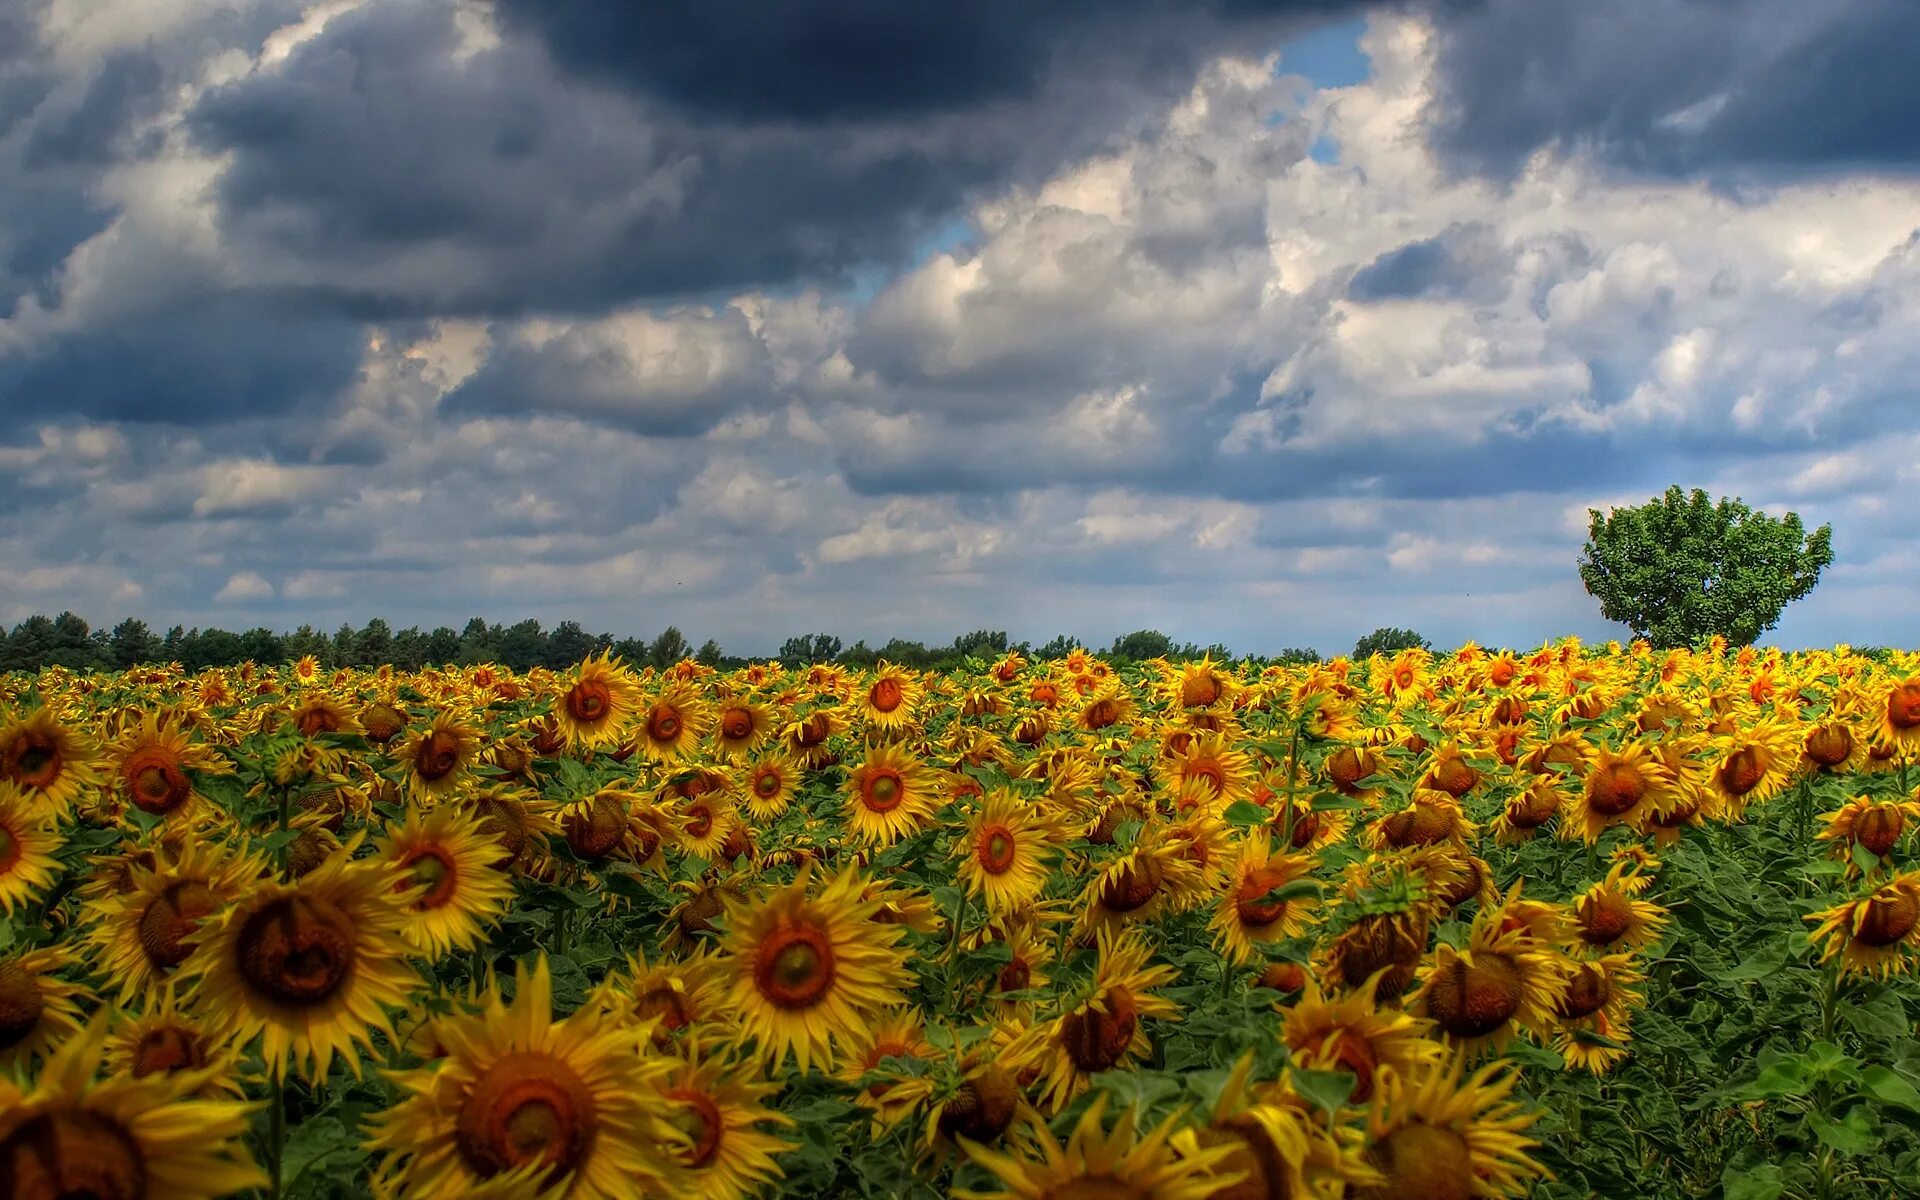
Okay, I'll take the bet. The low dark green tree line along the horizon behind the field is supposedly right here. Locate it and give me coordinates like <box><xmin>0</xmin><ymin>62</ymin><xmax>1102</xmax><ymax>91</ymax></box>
<box><xmin>0</xmin><ymin>612</ymin><xmax>1351</xmax><ymax>672</ymax></box>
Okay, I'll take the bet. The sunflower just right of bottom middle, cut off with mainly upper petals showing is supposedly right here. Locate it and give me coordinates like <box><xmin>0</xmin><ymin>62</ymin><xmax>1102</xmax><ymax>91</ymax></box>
<box><xmin>954</xmin><ymin>1094</ymin><xmax>1240</xmax><ymax>1200</ymax></box>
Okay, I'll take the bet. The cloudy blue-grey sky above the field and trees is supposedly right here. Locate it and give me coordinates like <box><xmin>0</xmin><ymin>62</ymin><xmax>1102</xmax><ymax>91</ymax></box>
<box><xmin>0</xmin><ymin>0</ymin><xmax>1920</xmax><ymax>653</ymax></box>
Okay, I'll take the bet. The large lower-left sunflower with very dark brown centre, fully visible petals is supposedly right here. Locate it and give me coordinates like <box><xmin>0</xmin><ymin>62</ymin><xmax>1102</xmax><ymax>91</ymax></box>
<box><xmin>182</xmin><ymin>837</ymin><xmax>419</xmax><ymax>1079</ymax></box>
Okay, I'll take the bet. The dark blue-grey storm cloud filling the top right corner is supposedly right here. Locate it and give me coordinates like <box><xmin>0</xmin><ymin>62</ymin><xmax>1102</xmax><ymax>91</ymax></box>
<box><xmin>1440</xmin><ymin>0</ymin><xmax>1920</xmax><ymax>179</ymax></box>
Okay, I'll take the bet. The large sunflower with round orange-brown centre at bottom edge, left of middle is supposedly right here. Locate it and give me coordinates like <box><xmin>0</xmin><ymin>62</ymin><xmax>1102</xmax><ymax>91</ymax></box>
<box><xmin>367</xmin><ymin>956</ymin><xmax>687</xmax><ymax>1200</ymax></box>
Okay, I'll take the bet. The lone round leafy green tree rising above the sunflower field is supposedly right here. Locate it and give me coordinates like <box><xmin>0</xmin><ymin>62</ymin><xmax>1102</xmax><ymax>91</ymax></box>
<box><xmin>1580</xmin><ymin>484</ymin><xmax>1834</xmax><ymax>649</ymax></box>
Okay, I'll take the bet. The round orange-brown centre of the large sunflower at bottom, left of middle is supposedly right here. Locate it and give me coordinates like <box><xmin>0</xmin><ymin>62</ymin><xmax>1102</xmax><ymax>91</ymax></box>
<box><xmin>455</xmin><ymin>1052</ymin><xmax>599</xmax><ymax>1177</ymax></box>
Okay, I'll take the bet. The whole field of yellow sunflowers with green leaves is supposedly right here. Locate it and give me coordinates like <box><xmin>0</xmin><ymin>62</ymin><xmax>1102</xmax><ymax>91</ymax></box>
<box><xmin>0</xmin><ymin>641</ymin><xmax>1920</xmax><ymax>1200</ymax></box>
